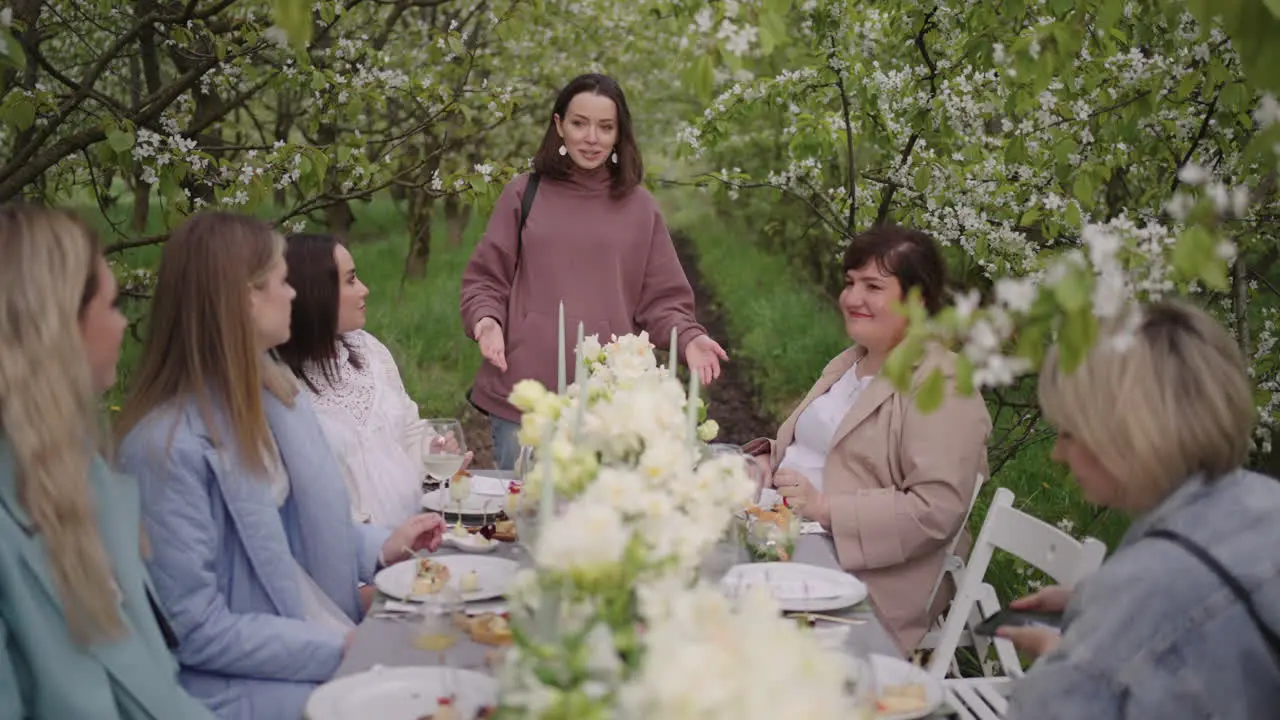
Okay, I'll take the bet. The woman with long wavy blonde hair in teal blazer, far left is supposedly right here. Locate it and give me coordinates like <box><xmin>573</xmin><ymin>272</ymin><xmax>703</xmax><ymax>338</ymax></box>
<box><xmin>0</xmin><ymin>208</ymin><xmax>209</xmax><ymax>720</ymax></box>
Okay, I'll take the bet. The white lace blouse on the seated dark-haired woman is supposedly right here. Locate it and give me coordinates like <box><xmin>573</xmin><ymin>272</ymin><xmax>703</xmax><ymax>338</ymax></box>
<box><xmin>305</xmin><ymin>331</ymin><xmax>431</xmax><ymax>528</ymax></box>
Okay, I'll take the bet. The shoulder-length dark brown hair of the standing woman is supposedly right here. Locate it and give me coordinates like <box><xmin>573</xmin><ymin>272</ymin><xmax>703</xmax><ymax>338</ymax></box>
<box><xmin>534</xmin><ymin>73</ymin><xmax>644</xmax><ymax>197</ymax></box>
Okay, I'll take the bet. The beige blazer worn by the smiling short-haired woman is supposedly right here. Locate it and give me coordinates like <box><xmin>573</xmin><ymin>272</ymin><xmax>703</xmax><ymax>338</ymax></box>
<box><xmin>746</xmin><ymin>346</ymin><xmax>991</xmax><ymax>653</ymax></box>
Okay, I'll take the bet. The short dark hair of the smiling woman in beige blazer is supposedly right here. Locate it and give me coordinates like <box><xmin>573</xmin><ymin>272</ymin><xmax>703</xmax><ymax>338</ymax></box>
<box><xmin>844</xmin><ymin>224</ymin><xmax>947</xmax><ymax>315</ymax></box>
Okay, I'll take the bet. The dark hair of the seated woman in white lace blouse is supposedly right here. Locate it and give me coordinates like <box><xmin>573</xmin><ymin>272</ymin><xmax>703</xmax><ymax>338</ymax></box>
<box><xmin>275</xmin><ymin>233</ymin><xmax>364</xmax><ymax>393</ymax></box>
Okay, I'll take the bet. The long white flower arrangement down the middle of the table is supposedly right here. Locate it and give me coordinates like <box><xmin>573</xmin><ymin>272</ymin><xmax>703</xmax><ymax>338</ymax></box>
<box><xmin>499</xmin><ymin>333</ymin><xmax>850</xmax><ymax>720</ymax></box>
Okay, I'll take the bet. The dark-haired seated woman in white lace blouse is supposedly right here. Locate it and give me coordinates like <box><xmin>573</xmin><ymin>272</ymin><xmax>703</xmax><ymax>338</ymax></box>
<box><xmin>276</xmin><ymin>234</ymin><xmax>470</xmax><ymax>528</ymax></box>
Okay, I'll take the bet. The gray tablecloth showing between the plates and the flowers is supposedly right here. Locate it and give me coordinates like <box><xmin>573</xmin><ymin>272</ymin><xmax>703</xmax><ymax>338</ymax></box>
<box><xmin>337</xmin><ymin>536</ymin><xmax>901</xmax><ymax>678</ymax></box>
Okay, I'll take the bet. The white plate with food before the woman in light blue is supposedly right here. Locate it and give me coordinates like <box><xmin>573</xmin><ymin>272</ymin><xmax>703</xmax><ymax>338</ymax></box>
<box><xmin>374</xmin><ymin>555</ymin><xmax>520</xmax><ymax>602</ymax></box>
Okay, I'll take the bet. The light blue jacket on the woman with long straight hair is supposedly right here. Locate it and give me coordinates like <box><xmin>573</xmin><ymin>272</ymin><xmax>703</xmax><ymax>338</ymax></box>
<box><xmin>119</xmin><ymin>391</ymin><xmax>389</xmax><ymax>720</ymax></box>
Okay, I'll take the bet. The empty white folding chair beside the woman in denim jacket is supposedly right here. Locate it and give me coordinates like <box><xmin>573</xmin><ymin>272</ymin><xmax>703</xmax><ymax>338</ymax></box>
<box><xmin>928</xmin><ymin>488</ymin><xmax>1107</xmax><ymax>679</ymax></box>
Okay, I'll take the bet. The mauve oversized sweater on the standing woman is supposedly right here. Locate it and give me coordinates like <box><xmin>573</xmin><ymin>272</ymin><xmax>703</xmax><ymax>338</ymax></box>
<box><xmin>461</xmin><ymin>167</ymin><xmax>707</xmax><ymax>421</ymax></box>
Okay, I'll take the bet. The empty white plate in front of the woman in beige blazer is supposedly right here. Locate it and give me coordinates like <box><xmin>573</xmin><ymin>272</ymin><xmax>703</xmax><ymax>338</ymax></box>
<box><xmin>721</xmin><ymin>562</ymin><xmax>867</xmax><ymax>612</ymax></box>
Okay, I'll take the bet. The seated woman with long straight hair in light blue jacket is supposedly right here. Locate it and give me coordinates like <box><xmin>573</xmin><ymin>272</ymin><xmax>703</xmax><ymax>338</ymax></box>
<box><xmin>112</xmin><ymin>213</ymin><xmax>443</xmax><ymax>720</ymax></box>
